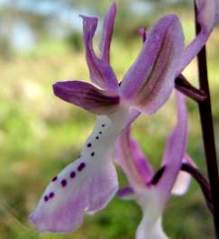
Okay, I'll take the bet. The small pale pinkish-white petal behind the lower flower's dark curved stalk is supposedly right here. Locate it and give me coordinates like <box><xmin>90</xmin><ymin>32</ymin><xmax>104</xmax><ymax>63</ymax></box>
<box><xmin>171</xmin><ymin>154</ymin><xmax>195</xmax><ymax>196</ymax></box>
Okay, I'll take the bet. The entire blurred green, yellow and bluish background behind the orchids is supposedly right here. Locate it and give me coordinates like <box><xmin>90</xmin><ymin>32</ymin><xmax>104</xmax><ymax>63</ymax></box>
<box><xmin>0</xmin><ymin>0</ymin><xmax>219</xmax><ymax>239</ymax></box>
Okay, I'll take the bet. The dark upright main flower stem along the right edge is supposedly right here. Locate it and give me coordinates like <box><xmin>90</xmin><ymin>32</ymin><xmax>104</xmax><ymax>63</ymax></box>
<box><xmin>195</xmin><ymin>3</ymin><xmax>219</xmax><ymax>239</ymax></box>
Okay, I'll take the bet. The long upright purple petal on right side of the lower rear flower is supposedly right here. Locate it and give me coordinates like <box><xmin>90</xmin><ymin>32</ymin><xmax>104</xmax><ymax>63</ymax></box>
<box><xmin>157</xmin><ymin>93</ymin><xmax>188</xmax><ymax>203</ymax></box>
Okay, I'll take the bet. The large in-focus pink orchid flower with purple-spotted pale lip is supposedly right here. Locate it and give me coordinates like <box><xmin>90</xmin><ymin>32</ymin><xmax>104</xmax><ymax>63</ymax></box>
<box><xmin>30</xmin><ymin>0</ymin><xmax>216</xmax><ymax>232</ymax></box>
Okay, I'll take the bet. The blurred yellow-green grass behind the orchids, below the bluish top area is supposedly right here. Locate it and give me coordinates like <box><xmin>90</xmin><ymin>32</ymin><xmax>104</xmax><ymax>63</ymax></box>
<box><xmin>0</xmin><ymin>13</ymin><xmax>219</xmax><ymax>239</ymax></box>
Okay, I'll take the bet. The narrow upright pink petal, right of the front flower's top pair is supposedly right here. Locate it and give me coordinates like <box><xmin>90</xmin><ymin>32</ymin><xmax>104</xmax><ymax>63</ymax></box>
<box><xmin>100</xmin><ymin>3</ymin><xmax>117</xmax><ymax>63</ymax></box>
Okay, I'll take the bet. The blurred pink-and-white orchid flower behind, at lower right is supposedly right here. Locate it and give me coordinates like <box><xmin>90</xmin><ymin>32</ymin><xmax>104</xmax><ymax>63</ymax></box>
<box><xmin>116</xmin><ymin>93</ymin><xmax>191</xmax><ymax>239</ymax></box>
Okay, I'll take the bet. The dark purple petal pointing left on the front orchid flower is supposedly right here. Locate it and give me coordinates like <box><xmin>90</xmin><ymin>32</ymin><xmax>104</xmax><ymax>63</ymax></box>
<box><xmin>53</xmin><ymin>81</ymin><xmax>119</xmax><ymax>114</ymax></box>
